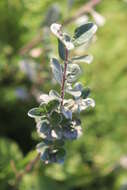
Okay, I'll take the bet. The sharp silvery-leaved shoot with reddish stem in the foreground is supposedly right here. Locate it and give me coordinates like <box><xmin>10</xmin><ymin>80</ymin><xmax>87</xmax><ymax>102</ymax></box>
<box><xmin>28</xmin><ymin>23</ymin><xmax>97</xmax><ymax>164</ymax></box>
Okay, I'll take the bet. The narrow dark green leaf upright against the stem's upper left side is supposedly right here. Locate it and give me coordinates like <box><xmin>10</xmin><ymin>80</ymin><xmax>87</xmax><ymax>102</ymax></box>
<box><xmin>58</xmin><ymin>39</ymin><xmax>66</xmax><ymax>60</ymax></box>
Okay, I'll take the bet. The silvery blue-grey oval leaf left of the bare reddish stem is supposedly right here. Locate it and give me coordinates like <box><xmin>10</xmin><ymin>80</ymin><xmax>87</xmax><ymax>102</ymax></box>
<box><xmin>51</xmin><ymin>58</ymin><xmax>63</xmax><ymax>84</ymax></box>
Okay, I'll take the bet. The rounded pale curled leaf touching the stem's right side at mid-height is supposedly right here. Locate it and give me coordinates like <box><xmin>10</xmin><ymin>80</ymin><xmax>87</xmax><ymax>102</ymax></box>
<box><xmin>67</xmin><ymin>64</ymin><xmax>81</xmax><ymax>83</ymax></box>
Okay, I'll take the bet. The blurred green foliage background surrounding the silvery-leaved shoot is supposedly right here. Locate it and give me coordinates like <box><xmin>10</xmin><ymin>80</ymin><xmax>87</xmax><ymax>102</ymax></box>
<box><xmin>0</xmin><ymin>0</ymin><xmax>127</xmax><ymax>190</ymax></box>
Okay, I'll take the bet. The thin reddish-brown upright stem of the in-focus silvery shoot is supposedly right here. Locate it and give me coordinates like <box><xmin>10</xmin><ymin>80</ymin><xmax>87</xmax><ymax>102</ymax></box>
<box><xmin>61</xmin><ymin>48</ymin><xmax>68</xmax><ymax>106</ymax></box>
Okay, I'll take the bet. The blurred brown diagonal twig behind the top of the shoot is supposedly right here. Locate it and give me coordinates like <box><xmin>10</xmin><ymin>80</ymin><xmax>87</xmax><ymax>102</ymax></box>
<box><xmin>19</xmin><ymin>0</ymin><xmax>101</xmax><ymax>56</ymax></box>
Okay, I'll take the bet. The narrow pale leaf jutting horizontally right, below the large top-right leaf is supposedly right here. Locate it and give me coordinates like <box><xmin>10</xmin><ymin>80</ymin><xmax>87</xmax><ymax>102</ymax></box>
<box><xmin>72</xmin><ymin>55</ymin><xmax>93</xmax><ymax>64</ymax></box>
